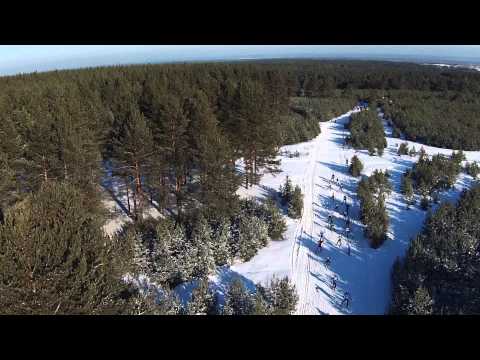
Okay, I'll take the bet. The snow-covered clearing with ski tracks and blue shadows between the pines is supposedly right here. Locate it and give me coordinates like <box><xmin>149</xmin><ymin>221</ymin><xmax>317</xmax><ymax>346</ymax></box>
<box><xmin>212</xmin><ymin>109</ymin><xmax>480</xmax><ymax>315</ymax></box>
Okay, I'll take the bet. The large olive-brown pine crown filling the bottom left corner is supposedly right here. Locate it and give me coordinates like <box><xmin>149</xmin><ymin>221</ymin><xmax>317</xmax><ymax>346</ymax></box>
<box><xmin>0</xmin><ymin>182</ymin><xmax>127</xmax><ymax>314</ymax></box>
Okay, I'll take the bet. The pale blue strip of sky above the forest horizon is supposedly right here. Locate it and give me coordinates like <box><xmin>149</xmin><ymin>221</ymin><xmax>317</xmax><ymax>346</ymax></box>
<box><xmin>0</xmin><ymin>45</ymin><xmax>480</xmax><ymax>75</ymax></box>
